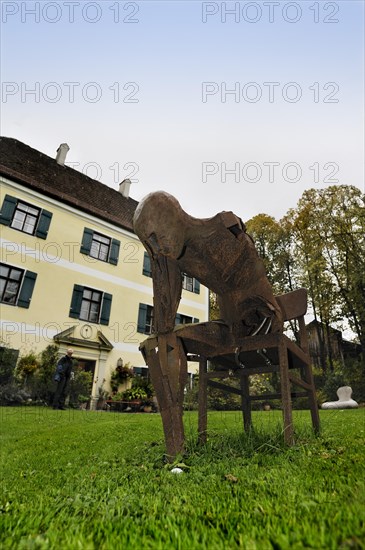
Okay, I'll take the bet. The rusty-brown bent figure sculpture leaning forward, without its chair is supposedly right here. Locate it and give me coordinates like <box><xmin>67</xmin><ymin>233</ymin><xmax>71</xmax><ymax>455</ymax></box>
<box><xmin>133</xmin><ymin>191</ymin><xmax>283</xmax><ymax>457</ymax></box>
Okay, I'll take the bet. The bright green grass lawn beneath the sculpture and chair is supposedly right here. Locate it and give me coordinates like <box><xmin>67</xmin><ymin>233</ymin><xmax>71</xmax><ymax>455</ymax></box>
<box><xmin>0</xmin><ymin>407</ymin><xmax>365</xmax><ymax>550</ymax></box>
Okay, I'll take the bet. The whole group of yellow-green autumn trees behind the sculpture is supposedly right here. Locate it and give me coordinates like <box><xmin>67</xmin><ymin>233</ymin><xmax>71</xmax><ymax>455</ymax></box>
<box><xmin>246</xmin><ymin>185</ymin><xmax>365</xmax><ymax>380</ymax></box>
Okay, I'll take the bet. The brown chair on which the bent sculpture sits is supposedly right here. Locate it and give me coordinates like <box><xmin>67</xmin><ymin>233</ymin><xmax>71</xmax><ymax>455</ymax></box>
<box><xmin>198</xmin><ymin>288</ymin><xmax>320</xmax><ymax>445</ymax></box>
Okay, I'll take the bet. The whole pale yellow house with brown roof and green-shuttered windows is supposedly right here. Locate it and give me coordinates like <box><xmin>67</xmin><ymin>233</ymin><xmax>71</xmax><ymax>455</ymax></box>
<box><xmin>0</xmin><ymin>138</ymin><xmax>209</xmax><ymax>407</ymax></box>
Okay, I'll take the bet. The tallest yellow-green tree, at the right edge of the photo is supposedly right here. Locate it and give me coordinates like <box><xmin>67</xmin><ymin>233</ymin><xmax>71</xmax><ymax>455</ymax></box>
<box><xmin>290</xmin><ymin>185</ymin><xmax>365</xmax><ymax>353</ymax></box>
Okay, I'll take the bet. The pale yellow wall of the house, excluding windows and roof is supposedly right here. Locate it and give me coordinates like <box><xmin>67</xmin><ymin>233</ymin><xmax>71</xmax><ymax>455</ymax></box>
<box><xmin>0</xmin><ymin>178</ymin><xmax>208</xmax><ymax>406</ymax></box>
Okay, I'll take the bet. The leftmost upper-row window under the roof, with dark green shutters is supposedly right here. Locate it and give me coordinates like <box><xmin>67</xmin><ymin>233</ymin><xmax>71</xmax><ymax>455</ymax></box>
<box><xmin>0</xmin><ymin>195</ymin><xmax>52</xmax><ymax>239</ymax></box>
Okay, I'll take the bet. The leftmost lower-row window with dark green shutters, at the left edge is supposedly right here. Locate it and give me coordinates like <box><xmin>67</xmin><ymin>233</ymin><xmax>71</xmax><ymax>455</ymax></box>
<box><xmin>0</xmin><ymin>264</ymin><xmax>37</xmax><ymax>308</ymax></box>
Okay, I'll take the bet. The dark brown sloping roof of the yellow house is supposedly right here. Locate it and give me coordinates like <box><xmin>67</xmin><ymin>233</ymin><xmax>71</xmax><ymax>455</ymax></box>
<box><xmin>0</xmin><ymin>137</ymin><xmax>138</xmax><ymax>232</ymax></box>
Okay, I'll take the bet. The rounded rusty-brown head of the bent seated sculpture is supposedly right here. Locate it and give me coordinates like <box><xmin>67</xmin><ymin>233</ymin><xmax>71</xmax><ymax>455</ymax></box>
<box><xmin>133</xmin><ymin>191</ymin><xmax>189</xmax><ymax>259</ymax></box>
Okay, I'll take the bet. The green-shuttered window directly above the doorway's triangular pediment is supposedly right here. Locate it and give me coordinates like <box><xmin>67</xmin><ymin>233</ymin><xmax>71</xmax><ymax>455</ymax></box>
<box><xmin>69</xmin><ymin>285</ymin><xmax>113</xmax><ymax>325</ymax></box>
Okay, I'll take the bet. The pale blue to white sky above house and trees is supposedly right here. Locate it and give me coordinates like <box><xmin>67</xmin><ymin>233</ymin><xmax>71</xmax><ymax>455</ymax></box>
<box><xmin>0</xmin><ymin>0</ymin><xmax>364</xmax><ymax>220</ymax></box>
